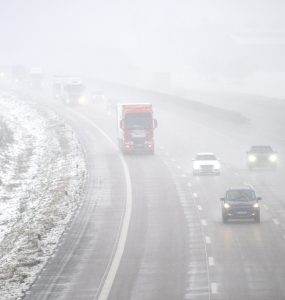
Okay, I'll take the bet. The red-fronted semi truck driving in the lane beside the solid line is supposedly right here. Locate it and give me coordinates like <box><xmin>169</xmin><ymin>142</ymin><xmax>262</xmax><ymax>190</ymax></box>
<box><xmin>117</xmin><ymin>103</ymin><xmax>157</xmax><ymax>154</ymax></box>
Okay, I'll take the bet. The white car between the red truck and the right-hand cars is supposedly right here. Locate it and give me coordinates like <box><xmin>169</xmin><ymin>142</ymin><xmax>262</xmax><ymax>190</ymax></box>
<box><xmin>192</xmin><ymin>152</ymin><xmax>221</xmax><ymax>175</ymax></box>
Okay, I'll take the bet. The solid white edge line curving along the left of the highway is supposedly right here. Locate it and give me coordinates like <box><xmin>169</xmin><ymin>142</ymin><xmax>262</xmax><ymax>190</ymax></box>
<box><xmin>72</xmin><ymin>113</ymin><xmax>132</xmax><ymax>300</ymax></box>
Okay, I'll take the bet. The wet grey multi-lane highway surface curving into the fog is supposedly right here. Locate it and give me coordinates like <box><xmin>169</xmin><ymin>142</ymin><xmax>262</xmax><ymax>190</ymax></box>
<box><xmin>25</xmin><ymin>87</ymin><xmax>285</xmax><ymax>299</ymax></box>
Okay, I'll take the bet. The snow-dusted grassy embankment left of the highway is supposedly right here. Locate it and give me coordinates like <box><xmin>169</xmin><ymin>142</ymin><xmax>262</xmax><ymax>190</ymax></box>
<box><xmin>0</xmin><ymin>95</ymin><xmax>86</xmax><ymax>299</ymax></box>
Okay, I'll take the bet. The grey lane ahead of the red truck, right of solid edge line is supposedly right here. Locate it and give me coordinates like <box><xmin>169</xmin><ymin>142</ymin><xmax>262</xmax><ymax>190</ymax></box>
<box><xmin>107</xmin><ymin>155</ymin><xmax>188</xmax><ymax>299</ymax></box>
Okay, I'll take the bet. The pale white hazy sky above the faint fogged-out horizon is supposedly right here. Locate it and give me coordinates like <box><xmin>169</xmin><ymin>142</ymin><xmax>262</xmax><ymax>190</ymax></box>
<box><xmin>0</xmin><ymin>0</ymin><xmax>285</xmax><ymax>78</ymax></box>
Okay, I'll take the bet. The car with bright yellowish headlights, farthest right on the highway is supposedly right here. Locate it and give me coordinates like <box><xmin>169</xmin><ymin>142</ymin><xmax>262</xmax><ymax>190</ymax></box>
<box><xmin>247</xmin><ymin>145</ymin><xmax>278</xmax><ymax>170</ymax></box>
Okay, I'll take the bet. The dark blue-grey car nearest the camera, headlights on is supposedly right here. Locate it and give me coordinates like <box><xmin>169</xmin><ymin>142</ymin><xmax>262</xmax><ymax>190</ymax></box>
<box><xmin>221</xmin><ymin>187</ymin><xmax>261</xmax><ymax>223</ymax></box>
